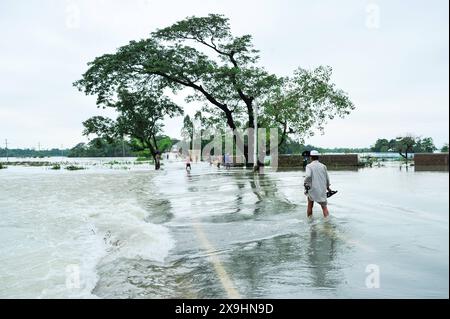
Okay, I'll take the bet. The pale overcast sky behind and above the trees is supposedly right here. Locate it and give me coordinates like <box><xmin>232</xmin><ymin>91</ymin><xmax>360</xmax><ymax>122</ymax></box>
<box><xmin>0</xmin><ymin>0</ymin><xmax>449</xmax><ymax>149</ymax></box>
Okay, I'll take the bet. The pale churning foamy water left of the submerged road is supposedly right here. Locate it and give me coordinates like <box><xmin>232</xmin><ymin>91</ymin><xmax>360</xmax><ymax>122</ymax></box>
<box><xmin>0</xmin><ymin>170</ymin><xmax>174</xmax><ymax>298</ymax></box>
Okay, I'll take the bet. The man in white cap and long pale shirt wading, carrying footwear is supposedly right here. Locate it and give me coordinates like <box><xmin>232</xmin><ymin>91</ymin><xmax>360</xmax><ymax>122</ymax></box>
<box><xmin>304</xmin><ymin>151</ymin><xmax>332</xmax><ymax>217</ymax></box>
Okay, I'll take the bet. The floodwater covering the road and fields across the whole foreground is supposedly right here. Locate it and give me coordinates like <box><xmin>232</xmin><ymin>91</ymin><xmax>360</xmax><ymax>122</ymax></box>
<box><xmin>0</xmin><ymin>160</ymin><xmax>449</xmax><ymax>298</ymax></box>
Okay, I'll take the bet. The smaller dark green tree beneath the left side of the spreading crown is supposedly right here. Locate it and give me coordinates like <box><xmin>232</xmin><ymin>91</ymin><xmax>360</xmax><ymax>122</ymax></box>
<box><xmin>83</xmin><ymin>89</ymin><xmax>183</xmax><ymax>169</ymax></box>
